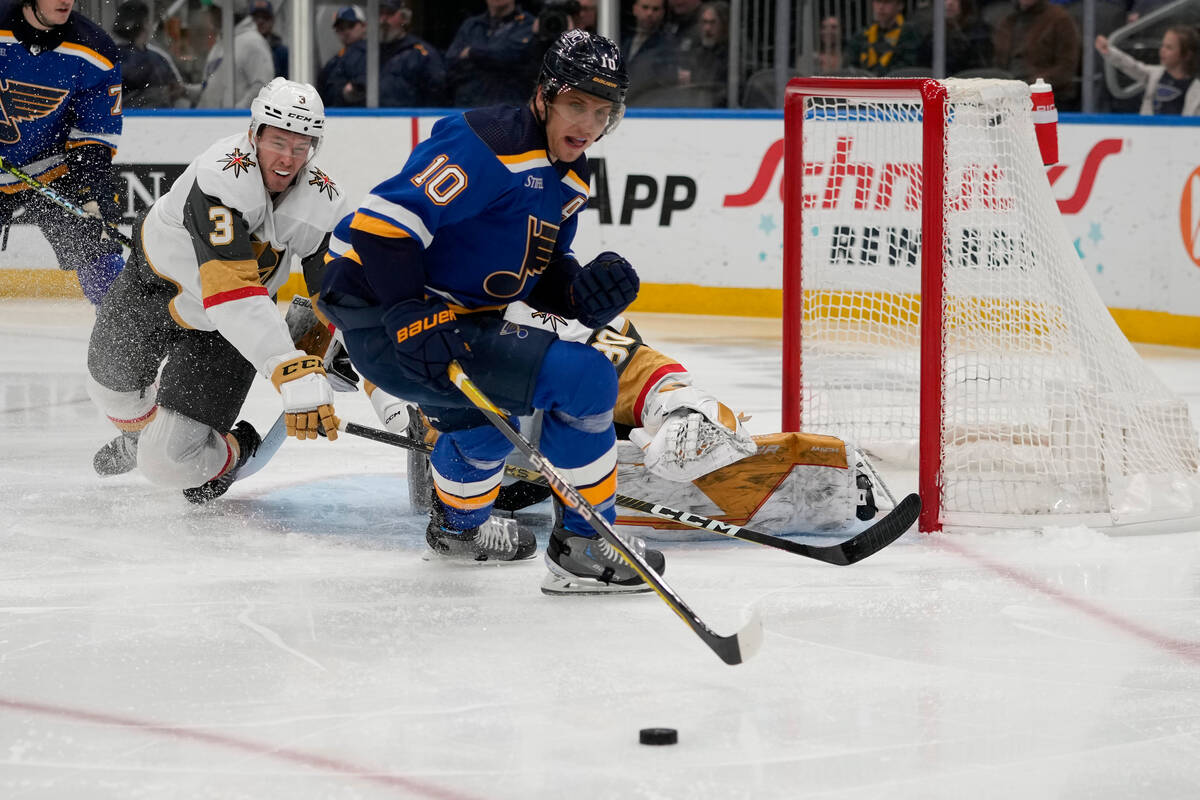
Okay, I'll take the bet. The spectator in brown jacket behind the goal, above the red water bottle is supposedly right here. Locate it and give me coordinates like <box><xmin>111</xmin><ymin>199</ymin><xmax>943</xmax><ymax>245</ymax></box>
<box><xmin>992</xmin><ymin>0</ymin><xmax>1080</xmax><ymax>105</ymax></box>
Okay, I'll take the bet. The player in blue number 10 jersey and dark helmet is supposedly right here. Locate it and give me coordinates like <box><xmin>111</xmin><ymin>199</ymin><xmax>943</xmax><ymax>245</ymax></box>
<box><xmin>318</xmin><ymin>30</ymin><xmax>664</xmax><ymax>594</ymax></box>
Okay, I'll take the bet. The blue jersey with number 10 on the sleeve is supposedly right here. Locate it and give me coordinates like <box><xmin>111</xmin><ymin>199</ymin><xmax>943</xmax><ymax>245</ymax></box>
<box><xmin>324</xmin><ymin>106</ymin><xmax>590</xmax><ymax>312</ymax></box>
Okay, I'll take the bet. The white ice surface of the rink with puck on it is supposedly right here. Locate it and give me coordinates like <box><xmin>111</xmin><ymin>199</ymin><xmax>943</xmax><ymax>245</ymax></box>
<box><xmin>0</xmin><ymin>300</ymin><xmax>1200</xmax><ymax>800</ymax></box>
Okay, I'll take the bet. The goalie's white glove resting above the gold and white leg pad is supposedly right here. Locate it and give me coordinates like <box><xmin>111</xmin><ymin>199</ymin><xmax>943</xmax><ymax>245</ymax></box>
<box><xmin>629</xmin><ymin>384</ymin><xmax>757</xmax><ymax>483</ymax></box>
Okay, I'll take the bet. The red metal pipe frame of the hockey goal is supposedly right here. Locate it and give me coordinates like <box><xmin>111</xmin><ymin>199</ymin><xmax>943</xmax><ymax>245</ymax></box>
<box><xmin>782</xmin><ymin>78</ymin><xmax>947</xmax><ymax>533</ymax></box>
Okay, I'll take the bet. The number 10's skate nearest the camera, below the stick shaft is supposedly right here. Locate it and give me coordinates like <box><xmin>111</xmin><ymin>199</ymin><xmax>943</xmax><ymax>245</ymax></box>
<box><xmin>541</xmin><ymin>525</ymin><xmax>666</xmax><ymax>595</ymax></box>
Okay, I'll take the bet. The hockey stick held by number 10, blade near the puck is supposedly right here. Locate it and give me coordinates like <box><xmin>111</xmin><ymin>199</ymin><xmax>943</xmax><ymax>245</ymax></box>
<box><xmin>448</xmin><ymin>361</ymin><xmax>762</xmax><ymax>664</ymax></box>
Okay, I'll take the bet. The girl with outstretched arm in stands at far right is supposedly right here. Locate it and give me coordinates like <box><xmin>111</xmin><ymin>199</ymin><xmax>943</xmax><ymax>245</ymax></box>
<box><xmin>1096</xmin><ymin>25</ymin><xmax>1200</xmax><ymax>116</ymax></box>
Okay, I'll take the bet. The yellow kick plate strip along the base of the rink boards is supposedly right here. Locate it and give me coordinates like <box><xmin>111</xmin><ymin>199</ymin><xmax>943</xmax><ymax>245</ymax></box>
<box><xmin>7</xmin><ymin>269</ymin><xmax>1200</xmax><ymax>348</ymax></box>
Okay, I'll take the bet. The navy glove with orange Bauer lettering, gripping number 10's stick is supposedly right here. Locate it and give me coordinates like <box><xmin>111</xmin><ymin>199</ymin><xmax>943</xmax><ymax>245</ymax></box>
<box><xmin>383</xmin><ymin>300</ymin><xmax>470</xmax><ymax>393</ymax></box>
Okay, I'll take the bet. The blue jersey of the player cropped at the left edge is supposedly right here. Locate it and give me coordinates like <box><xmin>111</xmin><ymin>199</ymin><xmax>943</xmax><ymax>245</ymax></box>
<box><xmin>0</xmin><ymin>2</ymin><xmax>121</xmax><ymax>193</ymax></box>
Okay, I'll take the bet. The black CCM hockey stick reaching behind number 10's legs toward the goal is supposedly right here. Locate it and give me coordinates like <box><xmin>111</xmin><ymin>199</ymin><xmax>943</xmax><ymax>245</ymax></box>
<box><xmin>338</xmin><ymin>420</ymin><xmax>920</xmax><ymax>566</ymax></box>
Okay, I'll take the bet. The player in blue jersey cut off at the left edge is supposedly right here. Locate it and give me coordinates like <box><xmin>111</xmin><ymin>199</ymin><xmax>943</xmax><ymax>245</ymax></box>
<box><xmin>0</xmin><ymin>0</ymin><xmax>125</xmax><ymax>305</ymax></box>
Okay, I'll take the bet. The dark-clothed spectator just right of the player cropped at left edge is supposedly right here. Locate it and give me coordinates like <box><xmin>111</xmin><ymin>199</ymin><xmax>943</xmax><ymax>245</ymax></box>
<box><xmin>113</xmin><ymin>0</ymin><xmax>186</xmax><ymax>108</ymax></box>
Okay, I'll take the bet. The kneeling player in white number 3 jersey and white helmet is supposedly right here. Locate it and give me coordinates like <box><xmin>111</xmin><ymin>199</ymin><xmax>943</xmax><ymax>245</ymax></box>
<box><xmin>88</xmin><ymin>78</ymin><xmax>348</xmax><ymax>503</ymax></box>
